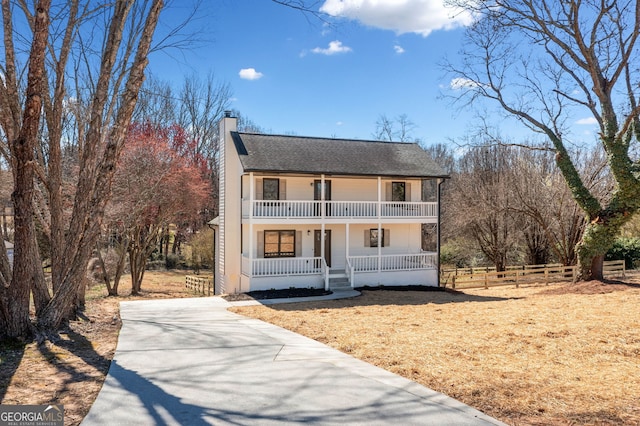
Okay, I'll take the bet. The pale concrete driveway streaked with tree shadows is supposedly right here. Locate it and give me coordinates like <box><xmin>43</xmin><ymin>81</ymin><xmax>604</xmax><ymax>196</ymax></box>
<box><xmin>82</xmin><ymin>293</ymin><xmax>502</xmax><ymax>426</ymax></box>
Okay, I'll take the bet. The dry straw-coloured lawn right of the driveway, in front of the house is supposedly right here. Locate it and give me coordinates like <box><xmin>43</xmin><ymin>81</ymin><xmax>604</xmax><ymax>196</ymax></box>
<box><xmin>233</xmin><ymin>282</ymin><xmax>640</xmax><ymax>425</ymax></box>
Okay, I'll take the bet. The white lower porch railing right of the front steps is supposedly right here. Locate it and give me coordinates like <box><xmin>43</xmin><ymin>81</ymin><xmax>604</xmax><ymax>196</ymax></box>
<box><xmin>348</xmin><ymin>253</ymin><xmax>437</xmax><ymax>272</ymax></box>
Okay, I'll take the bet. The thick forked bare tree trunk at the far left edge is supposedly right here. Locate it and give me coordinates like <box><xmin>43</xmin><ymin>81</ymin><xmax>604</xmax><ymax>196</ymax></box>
<box><xmin>0</xmin><ymin>0</ymin><xmax>51</xmax><ymax>338</ymax></box>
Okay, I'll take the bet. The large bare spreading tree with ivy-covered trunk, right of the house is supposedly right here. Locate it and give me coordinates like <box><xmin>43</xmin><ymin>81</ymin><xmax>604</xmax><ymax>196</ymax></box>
<box><xmin>448</xmin><ymin>0</ymin><xmax>640</xmax><ymax>279</ymax></box>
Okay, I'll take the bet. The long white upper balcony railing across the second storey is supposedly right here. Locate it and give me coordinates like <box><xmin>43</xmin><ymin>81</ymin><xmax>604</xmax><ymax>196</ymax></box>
<box><xmin>242</xmin><ymin>200</ymin><xmax>438</xmax><ymax>219</ymax></box>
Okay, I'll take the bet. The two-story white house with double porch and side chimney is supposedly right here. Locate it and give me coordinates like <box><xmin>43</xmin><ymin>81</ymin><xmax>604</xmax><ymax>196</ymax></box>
<box><xmin>215</xmin><ymin>114</ymin><xmax>447</xmax><ymax>294</ymax></box>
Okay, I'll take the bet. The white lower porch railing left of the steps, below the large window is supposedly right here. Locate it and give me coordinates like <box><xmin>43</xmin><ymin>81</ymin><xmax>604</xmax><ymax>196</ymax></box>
<box><xmin>242</xmin><ymin>257</ymin><xmax>326</xmax><ymax>277</ymax></box>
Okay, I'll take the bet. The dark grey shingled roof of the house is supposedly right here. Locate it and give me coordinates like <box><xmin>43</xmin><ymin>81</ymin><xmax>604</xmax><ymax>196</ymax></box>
<box><xmin>231</xmin><ymin>132</ymin><xmax>447</xmax><ymax>177</ymax></box>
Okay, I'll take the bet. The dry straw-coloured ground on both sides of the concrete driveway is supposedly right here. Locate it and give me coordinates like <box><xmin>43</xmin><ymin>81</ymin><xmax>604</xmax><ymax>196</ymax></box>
<box><xmin>0</xmin><ymin>272</ymin><xmax>640</xmax><ymax>425</ymax></box>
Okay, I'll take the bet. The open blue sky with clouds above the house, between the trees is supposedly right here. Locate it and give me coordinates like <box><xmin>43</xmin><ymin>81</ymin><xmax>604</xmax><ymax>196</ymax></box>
<box><xmin>150</xmin><ymin>0</ymin><xmax>596</xmax><ymax>145</ymax></box>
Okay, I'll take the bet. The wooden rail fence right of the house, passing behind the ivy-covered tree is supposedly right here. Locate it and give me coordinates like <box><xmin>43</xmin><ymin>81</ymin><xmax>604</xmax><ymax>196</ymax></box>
<box><xmin>441</xmin><ymin>260</ymin><xmax>625</xmax><ymax>289</ymax></box>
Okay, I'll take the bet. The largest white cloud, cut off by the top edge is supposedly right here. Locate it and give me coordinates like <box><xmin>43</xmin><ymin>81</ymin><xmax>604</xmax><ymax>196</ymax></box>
<box><xmin>320</xmin><ymin>0</ymin><xmax>473</xmax><ymax>37</ymax></box>
